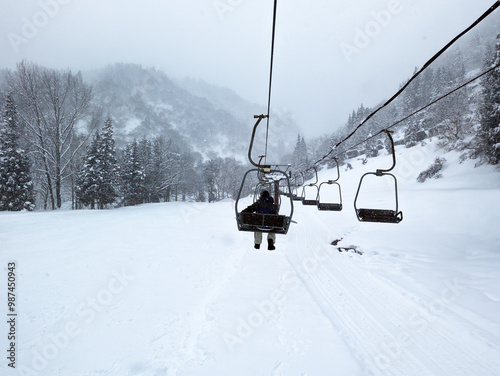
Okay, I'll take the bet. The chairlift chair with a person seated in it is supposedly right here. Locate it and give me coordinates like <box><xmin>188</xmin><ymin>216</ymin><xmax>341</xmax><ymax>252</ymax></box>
<box><xmin>235</xmin><ymin>115</ymin><xmax>293</xmax><ymax>234</ymax></box>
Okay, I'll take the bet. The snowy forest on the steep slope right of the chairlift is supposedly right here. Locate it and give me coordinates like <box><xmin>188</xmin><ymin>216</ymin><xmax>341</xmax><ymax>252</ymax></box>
<box><xmin>290</xmin><ymin>34</ymin><xmax>500</xmax><ymax>175</ymax></box>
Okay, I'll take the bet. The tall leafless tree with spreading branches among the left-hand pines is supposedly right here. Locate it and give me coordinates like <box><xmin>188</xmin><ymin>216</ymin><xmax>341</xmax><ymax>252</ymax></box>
<box><xmin>8</xmin><ymin>61</ymin><xmax>100</xmax><ymax>209</ymax></box>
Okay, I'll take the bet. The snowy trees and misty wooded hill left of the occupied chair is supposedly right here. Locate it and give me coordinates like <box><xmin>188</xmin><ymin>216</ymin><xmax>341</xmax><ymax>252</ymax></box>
<box><xmin>0</xmin><ymin>61</ymin><xmax>264</xmax><ymax>210</ymax></box>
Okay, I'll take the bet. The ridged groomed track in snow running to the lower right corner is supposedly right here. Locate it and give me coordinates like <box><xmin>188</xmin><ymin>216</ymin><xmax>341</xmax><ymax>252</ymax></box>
<box><xmin>287</xmin><ymin>204</ymin><xmax>500</xmax><ymax>376</ymax></box>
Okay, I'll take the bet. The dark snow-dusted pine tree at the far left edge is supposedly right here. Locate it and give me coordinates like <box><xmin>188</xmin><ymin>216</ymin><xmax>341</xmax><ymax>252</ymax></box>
<box><xmin>0</xmin><ymin>95</ymin><xmax>35</xmax><ymax>211</ymax></box>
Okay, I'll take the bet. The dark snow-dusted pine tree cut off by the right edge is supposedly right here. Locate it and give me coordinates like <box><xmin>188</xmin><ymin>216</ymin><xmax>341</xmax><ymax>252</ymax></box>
<box><xmin>480</xmin><ymin>34</ymin><xmax>500</xmax><ymax>164</ymax></box>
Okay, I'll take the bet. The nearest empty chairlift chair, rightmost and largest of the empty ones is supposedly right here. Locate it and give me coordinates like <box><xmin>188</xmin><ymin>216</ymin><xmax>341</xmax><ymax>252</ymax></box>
<box><xmin>354</xmin><ymin>129</ymin><xmax>403</xmax><ymax>223</ymax></box>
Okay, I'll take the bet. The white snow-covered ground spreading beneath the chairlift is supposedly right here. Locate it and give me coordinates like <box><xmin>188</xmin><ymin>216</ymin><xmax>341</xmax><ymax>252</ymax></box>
<box><xmin>0</xmin><ymin>142</ymin><xmax>500</xmax><ymax>376</ymax></box>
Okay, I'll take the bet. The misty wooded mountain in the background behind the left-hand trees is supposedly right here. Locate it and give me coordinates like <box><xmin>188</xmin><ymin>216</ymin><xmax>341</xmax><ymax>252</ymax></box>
<box><xmin>85</xmin><ymin>64</ymin><xmax>298</xmax><ymax>159</ymax></box>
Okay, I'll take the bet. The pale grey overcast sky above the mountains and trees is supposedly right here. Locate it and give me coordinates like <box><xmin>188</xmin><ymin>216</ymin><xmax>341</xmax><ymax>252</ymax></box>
<box><xmin>0</xmin><ymin>0</ymin><xmax>498</xmax><ymax>136</ymax></box>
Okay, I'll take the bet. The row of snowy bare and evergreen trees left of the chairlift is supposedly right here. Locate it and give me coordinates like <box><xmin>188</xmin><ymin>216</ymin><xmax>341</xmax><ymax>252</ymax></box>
<box><xmin>0</xmin><ymin>61</ymin><xmax>250</xmax><ymax>211</ymax></box>
